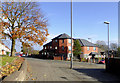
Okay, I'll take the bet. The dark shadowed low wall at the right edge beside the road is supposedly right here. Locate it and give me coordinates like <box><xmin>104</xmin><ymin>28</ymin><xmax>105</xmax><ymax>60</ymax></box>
<box><xmin>105</xmin><ymin>57</ymin><xmax>120</xmax><ymax>74</ymax></box>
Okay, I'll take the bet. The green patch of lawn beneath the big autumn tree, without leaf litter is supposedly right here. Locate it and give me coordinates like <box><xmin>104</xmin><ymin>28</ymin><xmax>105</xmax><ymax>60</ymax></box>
<box><xmin>0</xmin><ymin>56</ymin><xmax>18</xmax><ymax>66</ymax></box>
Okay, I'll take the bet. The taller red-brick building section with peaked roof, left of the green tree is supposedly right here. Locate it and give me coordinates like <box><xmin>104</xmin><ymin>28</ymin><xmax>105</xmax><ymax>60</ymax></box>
<box><xmin>39</xmin><ymin>33</ymin><xmax>73</xmax><ymax>60</ymax></box>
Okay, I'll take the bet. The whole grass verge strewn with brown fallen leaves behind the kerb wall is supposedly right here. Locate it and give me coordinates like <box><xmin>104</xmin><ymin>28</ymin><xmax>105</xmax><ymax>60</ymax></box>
<box><xmin>0</xmin><ymin>56</ymin><xmax>24</xmax><ymax>78</ymax></box>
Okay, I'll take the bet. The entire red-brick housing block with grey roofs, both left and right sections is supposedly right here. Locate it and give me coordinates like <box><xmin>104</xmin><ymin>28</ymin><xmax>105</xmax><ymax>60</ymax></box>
<box><xmin>39</xmin><ymin>33</ymin><xmax>98</xmax><ymax>60</ymax></box>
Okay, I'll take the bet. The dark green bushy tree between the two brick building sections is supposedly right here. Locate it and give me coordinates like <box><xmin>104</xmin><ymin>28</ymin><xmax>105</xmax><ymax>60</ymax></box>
<box><xmin>73</xmin><ymin>40</ymin><xmax>81</xmax><ymax>56</ymax></box>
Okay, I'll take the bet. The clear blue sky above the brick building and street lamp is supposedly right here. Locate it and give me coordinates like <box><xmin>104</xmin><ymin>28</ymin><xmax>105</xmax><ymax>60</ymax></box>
<box><xmin>1</xmin><ymin>2</ymin><xmax>118</xmax><ymax>51</ymax></box>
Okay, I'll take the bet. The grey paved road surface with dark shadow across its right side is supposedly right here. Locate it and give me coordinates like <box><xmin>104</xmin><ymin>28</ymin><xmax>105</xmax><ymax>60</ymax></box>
<box><xmin>26</xmin><ymin>58</ymin><xmax>120</xmax><ymax>82</ymax></box>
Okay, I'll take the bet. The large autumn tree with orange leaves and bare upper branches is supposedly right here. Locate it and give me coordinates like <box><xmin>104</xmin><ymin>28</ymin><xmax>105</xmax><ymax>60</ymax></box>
<box><xmin>0</xmin><ymin>2</ymin><xmax>49</xmax><ymax>56</ymax></box>
